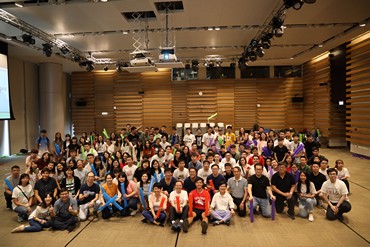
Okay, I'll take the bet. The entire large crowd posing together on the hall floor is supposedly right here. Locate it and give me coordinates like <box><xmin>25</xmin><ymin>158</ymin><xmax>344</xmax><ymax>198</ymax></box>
<box><xmin>4</xmin><ymin>125</ymin><xmax>351</xmax><ymax>234</ymax></box>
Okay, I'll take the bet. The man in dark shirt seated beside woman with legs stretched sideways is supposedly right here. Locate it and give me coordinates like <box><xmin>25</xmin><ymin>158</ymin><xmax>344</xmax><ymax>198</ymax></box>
<box><xmin>50</xmin><ymin>188</ymin><xmax>78</xmax><ymax>232</ymax></box>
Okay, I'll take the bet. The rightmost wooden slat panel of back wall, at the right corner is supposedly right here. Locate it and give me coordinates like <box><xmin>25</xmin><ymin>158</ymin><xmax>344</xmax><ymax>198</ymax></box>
<box><xmin>284</xmin><ymin>78</ymin><xmax>306</xmax><ymax>131</ymax></box>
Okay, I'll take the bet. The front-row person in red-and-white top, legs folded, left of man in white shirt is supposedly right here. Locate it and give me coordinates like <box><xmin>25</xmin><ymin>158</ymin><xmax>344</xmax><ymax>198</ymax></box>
<box><xmin>142</xmin><ymin>183</ymin><xmax>167</xmax><ymax>226</ymax></box>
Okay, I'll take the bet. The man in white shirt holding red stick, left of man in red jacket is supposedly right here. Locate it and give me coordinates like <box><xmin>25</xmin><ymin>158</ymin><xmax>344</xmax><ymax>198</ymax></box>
<box><xmin>169</xmin><ymin>180</ymin><xmax>189</xmax><ymax>231</ymax></box>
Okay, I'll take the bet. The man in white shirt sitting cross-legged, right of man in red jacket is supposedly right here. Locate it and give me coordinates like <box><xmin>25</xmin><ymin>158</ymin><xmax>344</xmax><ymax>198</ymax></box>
<box><xmin>211</xmin><ymin>182</ymin><xmax>235</xmax><ymax>226</ymax></box>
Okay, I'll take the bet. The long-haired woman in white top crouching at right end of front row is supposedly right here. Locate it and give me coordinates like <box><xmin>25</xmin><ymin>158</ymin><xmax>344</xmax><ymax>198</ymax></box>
<box><xmin>296</xmin><ymin>172</ymin><xmax>316</xmax><ymax>222</ymax></box>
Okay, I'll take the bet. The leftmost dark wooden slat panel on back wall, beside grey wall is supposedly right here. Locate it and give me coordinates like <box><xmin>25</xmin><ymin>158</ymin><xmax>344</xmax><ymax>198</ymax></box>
<box><xmin>72</xmin><ymin>72</ymin><xmax>95</xmax><ymax>135</ymax></box>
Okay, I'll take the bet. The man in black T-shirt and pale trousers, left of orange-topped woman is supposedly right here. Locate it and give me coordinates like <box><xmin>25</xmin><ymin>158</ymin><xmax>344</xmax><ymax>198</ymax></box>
<box><xmin>78</xmin><ymin>172</ymin><xmax>100</xmax><ymax>221</ymax></box>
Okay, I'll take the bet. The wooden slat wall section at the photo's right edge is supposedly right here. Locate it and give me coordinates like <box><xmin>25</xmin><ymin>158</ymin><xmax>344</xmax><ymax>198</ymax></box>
<box><xmin>346</xmin><ymin>30</ymin><xmax>370</xmax><ymax>147</ymax></box>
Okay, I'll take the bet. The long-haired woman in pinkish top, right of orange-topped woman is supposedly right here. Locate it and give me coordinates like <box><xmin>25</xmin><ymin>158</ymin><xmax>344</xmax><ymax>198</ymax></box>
<box><xmin>118</xmin><ymin>172</ymin><xmax>139</xmax><ymax>216</ymax></box>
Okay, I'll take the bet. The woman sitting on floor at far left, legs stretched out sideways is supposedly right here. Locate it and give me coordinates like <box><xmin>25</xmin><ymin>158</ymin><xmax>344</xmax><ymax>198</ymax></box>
<box><xmin>12</xmin><ymin>193</ymin><xmax>53</xmax><ymax>233</ymax></box>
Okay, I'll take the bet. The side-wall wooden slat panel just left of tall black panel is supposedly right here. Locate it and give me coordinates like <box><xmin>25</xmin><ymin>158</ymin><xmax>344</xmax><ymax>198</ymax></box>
<box><xmin>303</xmin><ymin>54</ymin><xmax>331</xmax><ymax>137</ymax></box>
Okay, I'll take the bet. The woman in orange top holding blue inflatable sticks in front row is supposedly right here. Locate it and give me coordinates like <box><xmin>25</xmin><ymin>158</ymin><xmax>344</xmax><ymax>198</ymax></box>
<box><xmin>100</xmin><ymin>174</ymin><xmax>124</xmax><ymax>219</ymax></box>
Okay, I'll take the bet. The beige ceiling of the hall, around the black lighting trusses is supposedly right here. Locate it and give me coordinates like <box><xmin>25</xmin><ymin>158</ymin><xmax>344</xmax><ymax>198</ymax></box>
<box><xmin>0</xmin><ymin>0</ymin><xmax>370</xmax><ymax>72</ymax></box>
